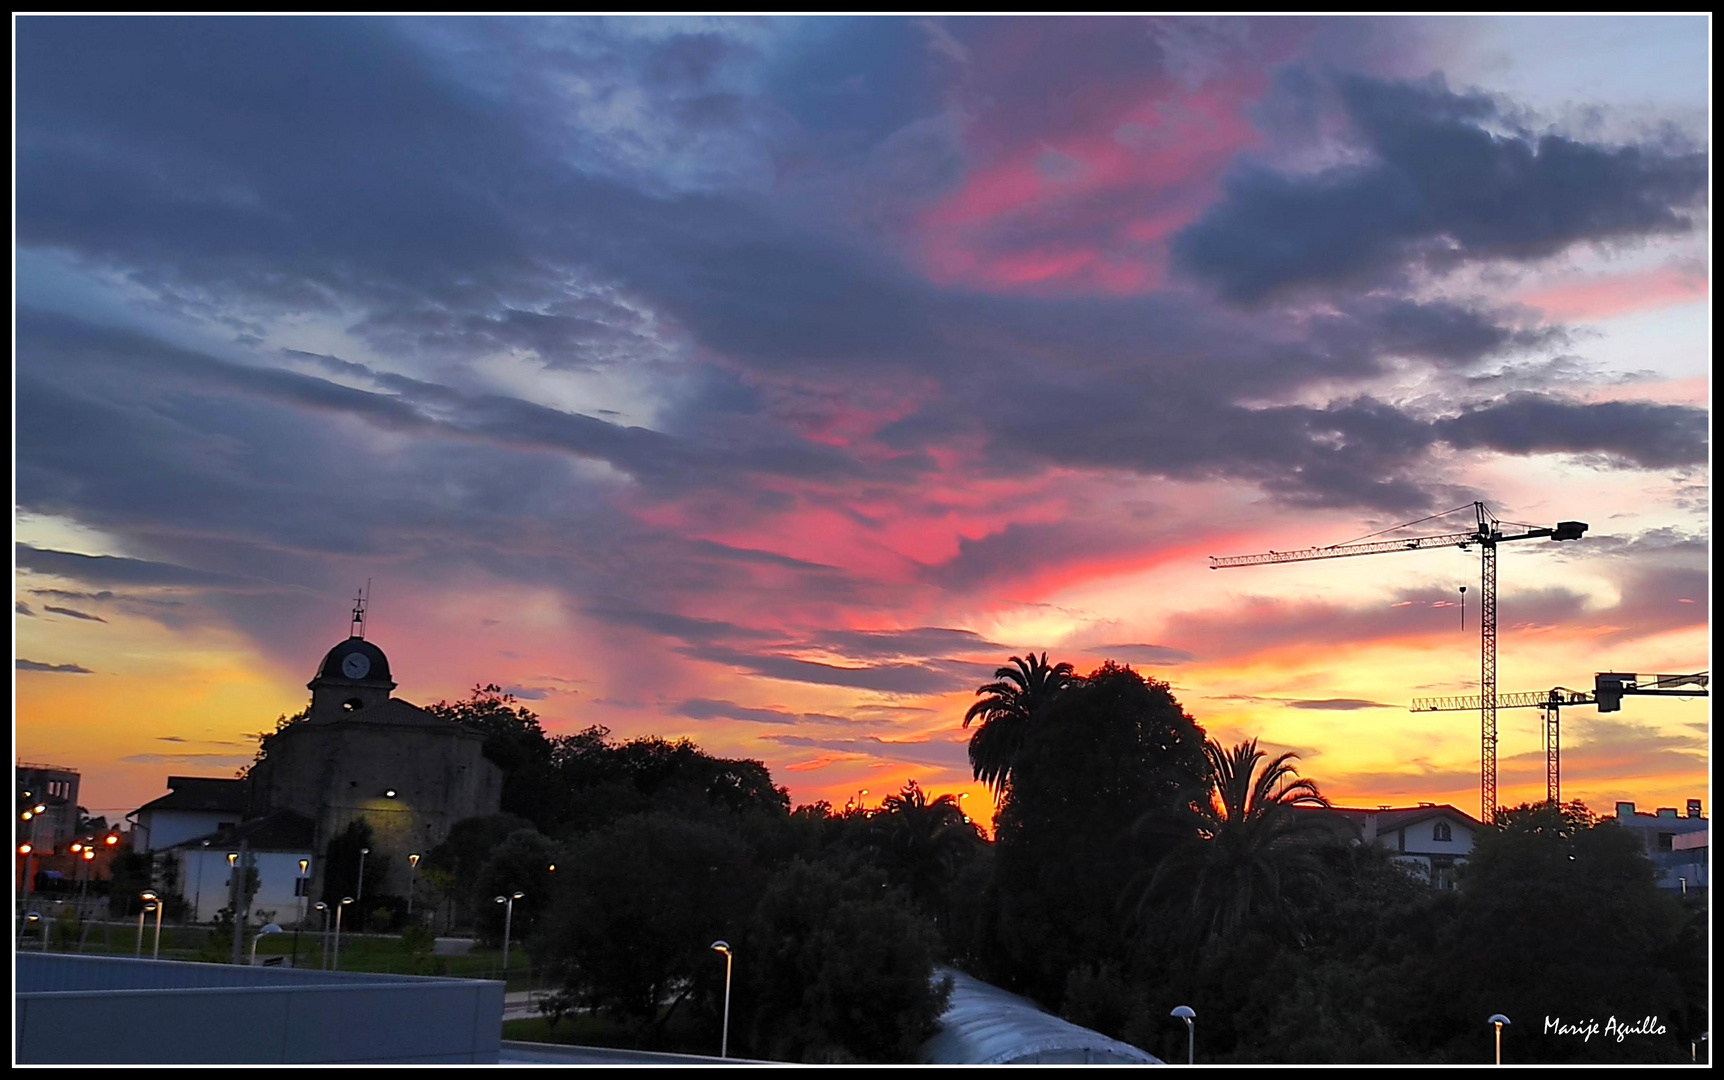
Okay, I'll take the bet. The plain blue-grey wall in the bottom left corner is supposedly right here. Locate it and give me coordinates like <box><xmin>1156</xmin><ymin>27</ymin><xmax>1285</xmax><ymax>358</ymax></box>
<box><xmin>14</xmin><ymin>952</ymin><xmax>503</xmax><ymax>1064</ymax></box>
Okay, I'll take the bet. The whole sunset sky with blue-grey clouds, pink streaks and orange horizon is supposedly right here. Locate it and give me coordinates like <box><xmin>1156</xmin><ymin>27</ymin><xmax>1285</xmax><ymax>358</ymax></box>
<box><xmin>14</xmin><ymin>17</ymin><xmax>1712</xmax><ymax>816</ymax></box>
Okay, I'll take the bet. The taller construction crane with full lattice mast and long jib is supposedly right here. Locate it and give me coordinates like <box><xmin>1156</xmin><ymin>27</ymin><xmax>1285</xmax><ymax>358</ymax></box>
<box><xmin>1209</xmin><ymin>502</ymin><xmax>1586</xmax><ymax>821</ymax></box>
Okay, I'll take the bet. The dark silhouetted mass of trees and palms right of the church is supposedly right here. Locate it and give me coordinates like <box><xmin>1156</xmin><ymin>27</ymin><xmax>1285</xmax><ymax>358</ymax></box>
<box><xmin>293</xmin><ymin>656</ymin><xmax>1708</xmax><ymax>1063</ymax></box>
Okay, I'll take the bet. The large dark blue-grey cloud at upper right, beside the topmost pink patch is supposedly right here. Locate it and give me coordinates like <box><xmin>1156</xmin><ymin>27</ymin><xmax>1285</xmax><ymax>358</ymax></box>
<box><xmin>1174</xmin><ymin>76</ymin><xmax>1707</xmax><ymax>302</ymax></box>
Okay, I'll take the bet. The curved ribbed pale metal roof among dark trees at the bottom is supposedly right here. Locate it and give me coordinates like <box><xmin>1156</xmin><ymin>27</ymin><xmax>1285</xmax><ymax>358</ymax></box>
<box><xmin>922</xmin><ymin>968</ymin><xmax>1165</xmax><ymax>1064</ymax></box>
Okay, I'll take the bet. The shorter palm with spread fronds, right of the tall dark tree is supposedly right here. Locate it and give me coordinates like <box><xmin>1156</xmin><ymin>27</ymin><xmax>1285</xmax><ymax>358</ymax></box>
<box><xmin>1138</xmin><ymin>738</ymin><xmax>1336</xmax><ymax>945</ymax></box>
